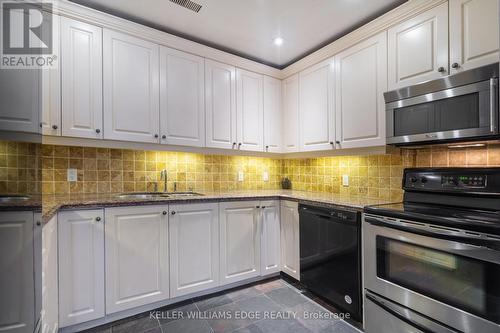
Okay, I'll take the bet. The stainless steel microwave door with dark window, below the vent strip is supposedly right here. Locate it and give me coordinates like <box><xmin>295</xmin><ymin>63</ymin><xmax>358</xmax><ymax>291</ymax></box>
<box><xmin>386</xmin><ymin>78</ymin><xmax>498</xmax><ymax>145</ymax></box>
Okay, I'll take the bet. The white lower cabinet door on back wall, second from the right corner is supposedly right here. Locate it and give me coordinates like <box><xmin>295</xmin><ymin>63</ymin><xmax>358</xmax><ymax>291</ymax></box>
<box><xmin>219</xmin><ymin>201</ymin><xmax>260</xmax><ymax>285</ymax></box>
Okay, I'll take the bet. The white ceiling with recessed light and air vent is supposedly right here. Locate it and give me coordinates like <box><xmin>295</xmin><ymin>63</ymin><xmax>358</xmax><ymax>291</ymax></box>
<box><xmin>72</xmin><ymin>0</ymin><xmax>405</xmax><ymax>68</ymax></box>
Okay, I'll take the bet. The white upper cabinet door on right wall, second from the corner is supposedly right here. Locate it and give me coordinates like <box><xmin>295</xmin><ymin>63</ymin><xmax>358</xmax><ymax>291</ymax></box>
<box><xmin>299</xmin><ymin>59</ymin><xmax>335</xmax><ymax>151</ymax></box>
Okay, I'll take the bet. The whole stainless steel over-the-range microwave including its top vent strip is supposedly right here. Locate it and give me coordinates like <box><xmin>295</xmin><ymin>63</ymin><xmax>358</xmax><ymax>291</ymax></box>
<box><xmin>384</xmin><ymin>63</ymin><xmax>499</xmax><ymax>146</ymax></box>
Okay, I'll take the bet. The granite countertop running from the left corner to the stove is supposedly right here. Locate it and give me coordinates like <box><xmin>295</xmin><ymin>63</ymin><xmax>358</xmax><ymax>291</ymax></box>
<box><xmin>42</xmin><ymin>190</ymin><xmax>390</xmax><ymax>223</ymax></box>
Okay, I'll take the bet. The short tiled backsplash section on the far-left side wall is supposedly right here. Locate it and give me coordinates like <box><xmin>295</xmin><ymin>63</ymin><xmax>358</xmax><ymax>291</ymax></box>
<box><xmin>0</xmin><ymin>141</ymin><xmax>41</xmax><ymax>194</ymax></box>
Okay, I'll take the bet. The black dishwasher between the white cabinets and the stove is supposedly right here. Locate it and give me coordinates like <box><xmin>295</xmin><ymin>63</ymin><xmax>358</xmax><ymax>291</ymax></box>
<box><xmin>299</xmin><ymin>205</ymin><xmax>361</xmax><ymax>321</ymax></box>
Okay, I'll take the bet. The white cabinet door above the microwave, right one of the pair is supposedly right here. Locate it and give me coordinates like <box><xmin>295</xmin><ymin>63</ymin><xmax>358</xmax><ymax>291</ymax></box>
<box><xmin>450</xmin><ymin>0</ymin><xmax>499</xmax><ymax>73</ymax></box>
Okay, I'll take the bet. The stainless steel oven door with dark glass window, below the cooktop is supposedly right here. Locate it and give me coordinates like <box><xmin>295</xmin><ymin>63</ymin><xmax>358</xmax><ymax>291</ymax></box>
<box><xmin>363</xmin><ymin>215</ymin><xmax>500</xmax><ymax>333</ymax></box>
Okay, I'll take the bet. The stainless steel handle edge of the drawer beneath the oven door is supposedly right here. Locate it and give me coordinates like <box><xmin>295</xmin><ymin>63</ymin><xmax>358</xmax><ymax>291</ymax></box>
<box><xmin>365</xmin><ymin>290</ymin><xmax>460</xmax><ymax>333</ymax></box>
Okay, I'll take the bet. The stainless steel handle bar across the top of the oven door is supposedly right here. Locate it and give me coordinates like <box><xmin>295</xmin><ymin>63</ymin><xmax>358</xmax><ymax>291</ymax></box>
<box><xmin>365</xmin><ymin>216</ymin><xmax>500</xmax><ymax>251</ymax></box>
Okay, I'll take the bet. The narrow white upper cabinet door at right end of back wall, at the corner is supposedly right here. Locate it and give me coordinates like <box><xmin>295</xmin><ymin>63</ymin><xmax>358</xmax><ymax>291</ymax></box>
<box><xmin>264</xmin><ymin>76</ymin><xmax>283</xmax><ymax>153</ymax></box>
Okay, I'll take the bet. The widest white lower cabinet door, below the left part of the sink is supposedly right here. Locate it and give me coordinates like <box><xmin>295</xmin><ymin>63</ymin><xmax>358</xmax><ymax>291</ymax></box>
<box><xmin>105</xmin><ymin>206</ymin><xmax>169</xmax><ymax>314</ymax></box>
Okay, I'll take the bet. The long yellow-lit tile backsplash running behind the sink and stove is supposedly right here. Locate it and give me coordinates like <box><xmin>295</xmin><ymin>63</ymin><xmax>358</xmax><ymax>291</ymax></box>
<box><xmin>42</xmin><ymin>144</ymin><xmax>500</xmax><ymax>201</ymax></box>
